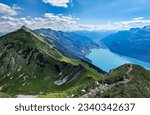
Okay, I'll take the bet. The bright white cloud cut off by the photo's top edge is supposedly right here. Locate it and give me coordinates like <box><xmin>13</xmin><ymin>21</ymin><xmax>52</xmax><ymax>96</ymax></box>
<box><xmin>43</xmin><ymin>0</ymin><xmax>70</xmax><ymax>8</ymax></box>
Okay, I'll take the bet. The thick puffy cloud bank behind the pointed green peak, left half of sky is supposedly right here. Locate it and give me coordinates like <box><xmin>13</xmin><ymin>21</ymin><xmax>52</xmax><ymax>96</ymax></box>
<box><xmin>0</xmin><ymin>13</ymin><xmax>79</xmax><ymax>31</ymax></box>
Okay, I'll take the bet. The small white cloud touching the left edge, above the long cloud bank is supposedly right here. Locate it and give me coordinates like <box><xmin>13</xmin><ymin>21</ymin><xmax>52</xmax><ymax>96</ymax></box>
<box><xmin>0</xmin><ymin>3</ymin><xmax>17</xmax><ymax>16</ymax></box>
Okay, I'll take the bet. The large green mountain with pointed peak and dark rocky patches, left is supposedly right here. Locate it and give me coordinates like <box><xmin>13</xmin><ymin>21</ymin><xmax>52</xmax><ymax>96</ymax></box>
<box><xmin>0</xmin><ymin>26</ymin><xmax>102</xmax><ymax>96</ymax></box>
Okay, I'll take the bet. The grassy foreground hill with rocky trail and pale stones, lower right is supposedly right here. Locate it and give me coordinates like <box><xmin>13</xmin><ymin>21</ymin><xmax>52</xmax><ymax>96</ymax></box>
<box><xmin>76</xmin><ymin>64</ymin><xmax>150</xmax><ymax>98</ymax></box>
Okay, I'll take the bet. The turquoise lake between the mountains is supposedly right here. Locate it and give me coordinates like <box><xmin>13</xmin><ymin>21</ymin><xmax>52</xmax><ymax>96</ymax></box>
<box><xmin>87</xmin><ymin>49</ymin><xmax>150</xmax><ymax>72</ymax></box>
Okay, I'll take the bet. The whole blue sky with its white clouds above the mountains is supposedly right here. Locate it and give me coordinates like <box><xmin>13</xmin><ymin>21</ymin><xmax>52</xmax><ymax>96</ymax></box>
<box><xmin>0</xmin><ymin>0</ymin><xmax>150</xmax><ymax>31</ymax></box>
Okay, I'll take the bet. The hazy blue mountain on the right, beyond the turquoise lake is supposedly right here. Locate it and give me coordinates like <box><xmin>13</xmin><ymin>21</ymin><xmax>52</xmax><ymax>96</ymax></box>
<box><xmin>101</xmin><ymin>26</ymin><xmax>150</xmax><ymax>62</ymax></box>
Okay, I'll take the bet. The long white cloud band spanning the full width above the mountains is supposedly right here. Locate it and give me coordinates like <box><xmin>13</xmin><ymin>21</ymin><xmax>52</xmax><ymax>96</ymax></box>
<box><xmin>0</xmin><ymin>13</ymin><xmax>150</xmax><ymax>32</ymax></box>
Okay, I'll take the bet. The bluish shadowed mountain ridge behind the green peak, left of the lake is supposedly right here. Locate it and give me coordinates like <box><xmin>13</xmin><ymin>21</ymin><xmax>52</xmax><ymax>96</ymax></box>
<box><xmin>34</xmin><ymin>29</ymin><xmax>100</xmax><ymax>59</ymax></box>
